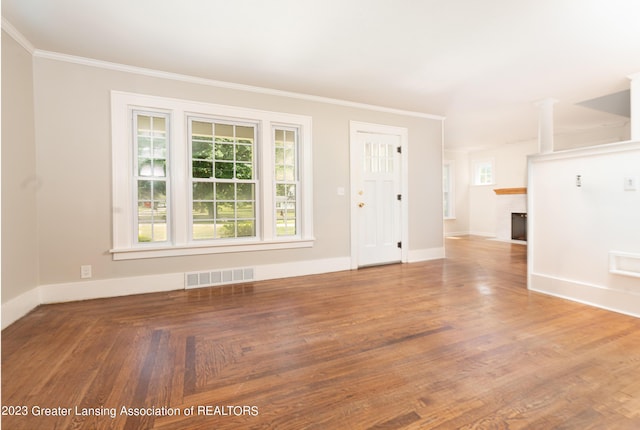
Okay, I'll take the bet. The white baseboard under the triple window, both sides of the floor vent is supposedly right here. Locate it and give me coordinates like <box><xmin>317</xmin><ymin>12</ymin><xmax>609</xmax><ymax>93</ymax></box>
<box><xmin>2</xmin><ymin>257</ymin><xmax>351</xmax><ymax>329</ymax></box>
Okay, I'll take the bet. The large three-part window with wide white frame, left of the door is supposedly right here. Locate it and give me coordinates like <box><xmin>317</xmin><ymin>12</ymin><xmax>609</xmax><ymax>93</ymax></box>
<box><xmin>111</xmin><ymin>91</ymin><xmax>313</xmax><ymax>259</ymax></box>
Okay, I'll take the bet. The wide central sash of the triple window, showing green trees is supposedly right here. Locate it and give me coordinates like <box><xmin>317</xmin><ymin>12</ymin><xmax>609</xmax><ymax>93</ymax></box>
<box><xmin>190</xmin><ymin>119</ymin><xmax>257</xmax><ymax>240</ymax></box>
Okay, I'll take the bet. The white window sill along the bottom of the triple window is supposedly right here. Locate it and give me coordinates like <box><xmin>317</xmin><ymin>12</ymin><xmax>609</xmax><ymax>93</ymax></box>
<box><xmin>114</xmin><ymin>239</ymin><xmax>315</xmax><ymax>260</ymax></box>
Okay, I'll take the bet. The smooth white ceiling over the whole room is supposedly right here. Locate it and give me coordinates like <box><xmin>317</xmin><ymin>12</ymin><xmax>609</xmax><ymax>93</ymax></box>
<box><xmin>2</xmin><ymin>0</ymin><xmax>640</xmax><ymax>148</ymax></box>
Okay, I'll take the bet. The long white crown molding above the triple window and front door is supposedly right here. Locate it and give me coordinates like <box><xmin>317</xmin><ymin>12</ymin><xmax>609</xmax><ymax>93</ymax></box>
<box><xmin>33</xmin><ymin>49</ymin><xmax>445</xmax><ymax>121</ymax></box>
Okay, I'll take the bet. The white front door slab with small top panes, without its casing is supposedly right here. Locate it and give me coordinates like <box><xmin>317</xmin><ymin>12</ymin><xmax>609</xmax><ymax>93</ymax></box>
<box><xmin>351</xmin><ymin>131</ymin><xmax>402</xmax><ymax>267</ymax></box>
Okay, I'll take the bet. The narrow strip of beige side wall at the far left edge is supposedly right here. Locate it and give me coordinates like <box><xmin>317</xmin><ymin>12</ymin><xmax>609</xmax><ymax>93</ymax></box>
<box><xmin>2</xmin><ymin>32</ymin><xmax>40</xmax><ymax>310</ymax></box>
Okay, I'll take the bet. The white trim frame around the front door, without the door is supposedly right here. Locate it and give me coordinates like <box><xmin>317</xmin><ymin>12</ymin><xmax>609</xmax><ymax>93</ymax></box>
<box><xmin>349</xmin><ymin>121</ymin><xmax>409</xmax><ymax>269</ymax></box>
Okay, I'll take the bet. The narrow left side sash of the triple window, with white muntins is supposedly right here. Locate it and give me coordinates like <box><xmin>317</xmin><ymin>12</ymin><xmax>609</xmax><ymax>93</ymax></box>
<box><xmin>133</xmin><ymin>111</ymin><xmax>169</xmax><ymax>243</ymax></box>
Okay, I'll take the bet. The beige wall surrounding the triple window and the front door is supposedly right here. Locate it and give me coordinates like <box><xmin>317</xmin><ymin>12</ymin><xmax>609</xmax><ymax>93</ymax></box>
<box><xmin>2</xmin><ymin>32</ymin><xmax>444</xmax><ymax>326</ymax></box>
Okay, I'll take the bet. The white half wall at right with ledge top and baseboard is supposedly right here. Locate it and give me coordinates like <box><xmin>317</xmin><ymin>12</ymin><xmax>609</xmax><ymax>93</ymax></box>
<box><xmin>528</xmin><ymin>142</ymin><xmax>640</xmax><ymax>316</ymax></box>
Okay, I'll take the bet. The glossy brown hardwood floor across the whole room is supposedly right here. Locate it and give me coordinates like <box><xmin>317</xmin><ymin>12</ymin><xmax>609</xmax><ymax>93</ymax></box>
<box><xmin>2</xmin><ymin>237</ymin><xmax>640</xmax><ymax>430</ymax></box>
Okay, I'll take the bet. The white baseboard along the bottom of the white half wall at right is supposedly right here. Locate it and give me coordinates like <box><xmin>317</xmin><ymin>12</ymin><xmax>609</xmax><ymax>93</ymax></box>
<box><xmin>529</xmin><ymin>273</ymin><xmax>640</xmax><ymax>318</ymax></box>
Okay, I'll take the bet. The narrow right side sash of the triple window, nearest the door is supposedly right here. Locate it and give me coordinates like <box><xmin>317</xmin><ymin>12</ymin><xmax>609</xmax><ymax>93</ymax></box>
<box><xmin>273</xmin><ymin>126</ymin><xmax>300</xmax><ymax>236</ymax></box>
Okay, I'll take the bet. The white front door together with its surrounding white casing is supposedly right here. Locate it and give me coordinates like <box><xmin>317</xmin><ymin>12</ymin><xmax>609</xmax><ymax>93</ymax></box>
<box><xmin>351</xmin><ymin>121</ymin><xmax>407</xmax><ymax>268</ymax></box>
